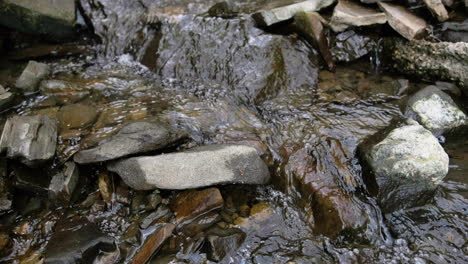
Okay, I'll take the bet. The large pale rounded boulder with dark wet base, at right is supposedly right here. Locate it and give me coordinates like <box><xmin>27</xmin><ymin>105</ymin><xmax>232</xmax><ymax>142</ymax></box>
<box><xmin>364</xmin><ymin>119</ymin><xmax>449</xmax><ymax>213</ymax></box>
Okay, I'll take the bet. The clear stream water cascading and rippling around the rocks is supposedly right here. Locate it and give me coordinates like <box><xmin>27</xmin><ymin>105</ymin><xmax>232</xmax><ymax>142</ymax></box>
<box><xmin>0</xmin><ymin>0</ymin><xmax>468</xmax><ymax>263</ymax></box>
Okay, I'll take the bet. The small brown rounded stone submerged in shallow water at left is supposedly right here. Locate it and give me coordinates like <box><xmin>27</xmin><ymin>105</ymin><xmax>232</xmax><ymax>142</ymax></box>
<box><xmin>57</xmin><ymin>104</ymin><xmax>98</xmax><ymax>129</ymax></box>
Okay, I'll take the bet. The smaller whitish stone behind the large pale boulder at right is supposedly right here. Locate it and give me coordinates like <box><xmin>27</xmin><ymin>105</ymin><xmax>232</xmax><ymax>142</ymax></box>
<box><xmin>406</xmin><ymin>85</ymin><xmax>468</xmax><ymax>134</ymax></box>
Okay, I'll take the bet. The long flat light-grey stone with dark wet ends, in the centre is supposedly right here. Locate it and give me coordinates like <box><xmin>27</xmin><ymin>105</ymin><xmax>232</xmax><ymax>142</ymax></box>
<box><xmin>108</xmin><ymin>145</ymin><xmax>270</xmax><ymax>190</ymax></box>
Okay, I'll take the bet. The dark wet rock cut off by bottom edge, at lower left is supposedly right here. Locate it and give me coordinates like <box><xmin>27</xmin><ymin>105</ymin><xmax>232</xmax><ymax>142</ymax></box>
<box><xmin>44</xmin><ymin>220</ymin><xmax>115</xmax><ymax>264</ymax></box>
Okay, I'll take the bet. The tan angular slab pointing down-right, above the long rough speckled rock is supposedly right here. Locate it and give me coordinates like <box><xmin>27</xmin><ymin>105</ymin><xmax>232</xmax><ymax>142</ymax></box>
<box><xmin>378</xmin><ymin>2</ymin><xmax>427</xmax><ymax>40</ymax></box>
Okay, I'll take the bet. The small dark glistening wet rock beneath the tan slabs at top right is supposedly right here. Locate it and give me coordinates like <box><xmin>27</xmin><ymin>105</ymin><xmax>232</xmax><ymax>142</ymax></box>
<box><xmin>330</xmin><ymin>30</ymin><xmax>377</xmax><ymax>62</ymax></box>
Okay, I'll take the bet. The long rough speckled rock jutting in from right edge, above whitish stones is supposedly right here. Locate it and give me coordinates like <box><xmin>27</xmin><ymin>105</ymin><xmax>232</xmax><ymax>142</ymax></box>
<box><xmin>383</xmin><ymin>38</ymin><xmax>468</xmax><ymax>89</ymax></box>
